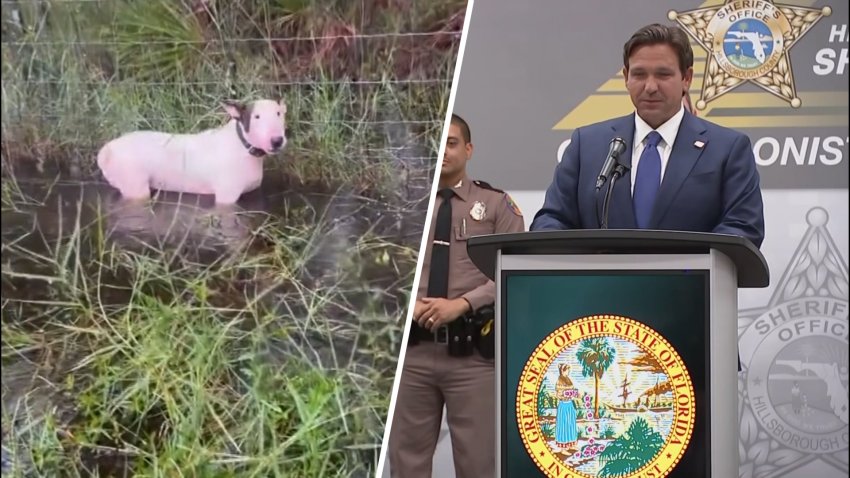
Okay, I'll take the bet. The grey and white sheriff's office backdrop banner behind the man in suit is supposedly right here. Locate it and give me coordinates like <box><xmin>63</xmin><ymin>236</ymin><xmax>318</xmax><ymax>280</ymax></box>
<box><xmin>448</xmin><ymin>0</ymin><xmax>850</xmax><ymax>478</ymax></box>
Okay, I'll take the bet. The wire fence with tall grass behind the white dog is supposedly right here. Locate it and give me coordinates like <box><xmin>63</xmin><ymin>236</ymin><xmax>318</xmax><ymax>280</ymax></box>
<box><xmin>0</xmin><ymin>0</ymin><xmax>464</xmax><ymax>201</ymax></box>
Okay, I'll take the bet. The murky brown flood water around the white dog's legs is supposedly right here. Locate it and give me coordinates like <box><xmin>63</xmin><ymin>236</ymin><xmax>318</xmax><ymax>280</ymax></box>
<box><xmin>2</xmin><ymin>161</ymin><xmax>427</xmax><ymax>476</ymax></box>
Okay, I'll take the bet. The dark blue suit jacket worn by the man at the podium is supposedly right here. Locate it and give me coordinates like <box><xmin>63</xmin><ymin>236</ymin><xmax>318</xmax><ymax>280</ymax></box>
<box><xmin>530</xmin><ymin>111</ymin><xmax>764</xmax><ymax>247</ymax></box>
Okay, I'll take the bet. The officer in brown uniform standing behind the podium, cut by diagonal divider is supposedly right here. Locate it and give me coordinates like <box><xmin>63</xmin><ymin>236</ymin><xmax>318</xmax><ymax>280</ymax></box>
<box><xmin>389</xmin><ymin>115</ymin><xmax>525</xmax><ymax>478</ymax></box>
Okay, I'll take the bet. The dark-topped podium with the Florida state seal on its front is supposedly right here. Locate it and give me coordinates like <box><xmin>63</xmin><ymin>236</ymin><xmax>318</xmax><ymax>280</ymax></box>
<box><xmin>467</xmin><ymin>230</ymin><xmax>769</xmax><ymax>478</ymax></box>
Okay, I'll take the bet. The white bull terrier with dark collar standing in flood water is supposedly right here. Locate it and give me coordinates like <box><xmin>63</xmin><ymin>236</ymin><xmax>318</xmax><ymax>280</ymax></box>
<box><xmin>97</xmin><ymin>99</ymin><xmax>286</xmax><ymax>205</ymax></box>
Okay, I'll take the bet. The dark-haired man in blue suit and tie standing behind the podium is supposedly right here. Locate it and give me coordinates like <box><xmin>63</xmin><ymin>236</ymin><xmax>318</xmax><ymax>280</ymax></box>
<box><xmin>530</xmin><ymin>24</ymin><xmax>764</xmax><ymax>247</ymax></box>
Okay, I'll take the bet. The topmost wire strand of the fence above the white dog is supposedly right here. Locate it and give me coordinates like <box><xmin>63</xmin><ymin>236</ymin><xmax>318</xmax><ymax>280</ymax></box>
<box><xmin>0</xmin><ymin>30</ymin><xmax>462</xmax><ymax>46</ymax></box>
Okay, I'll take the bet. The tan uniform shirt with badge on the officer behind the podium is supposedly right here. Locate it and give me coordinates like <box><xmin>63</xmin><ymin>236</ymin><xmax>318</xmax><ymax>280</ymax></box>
<box><xmin>417</xmin><ymin>177</ymin><xmax>525</xmax><ymax>312</ymax></box>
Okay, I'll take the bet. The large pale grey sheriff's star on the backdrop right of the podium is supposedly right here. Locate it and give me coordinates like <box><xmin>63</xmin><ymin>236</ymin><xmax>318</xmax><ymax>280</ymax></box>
<box><xmin>738</xmin><ymin>207</ymin><xmax>850</xmax><ymax>478</ymax></box>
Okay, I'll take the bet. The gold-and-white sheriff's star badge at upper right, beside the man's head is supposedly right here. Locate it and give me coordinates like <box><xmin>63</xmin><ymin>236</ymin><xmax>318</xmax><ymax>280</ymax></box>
<box><xmin>667</xmin><ymin>0</ymin><xmax>832</xmax><ymax>110</ymax></box>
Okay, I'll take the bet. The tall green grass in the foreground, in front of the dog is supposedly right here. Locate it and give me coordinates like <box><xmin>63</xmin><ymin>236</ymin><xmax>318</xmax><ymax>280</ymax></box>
<box><xmin>2</xmin><ymin>183</ymin><xmax>416</xmax><ymax>477</ymax></box>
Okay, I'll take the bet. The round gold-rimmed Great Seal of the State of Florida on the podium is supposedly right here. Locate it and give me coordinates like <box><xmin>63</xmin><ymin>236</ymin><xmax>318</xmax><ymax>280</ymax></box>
<box><xmin>516</xmin><ymin>315</ymin><xmax>696</xmax><ymax>478</ymax></box>
